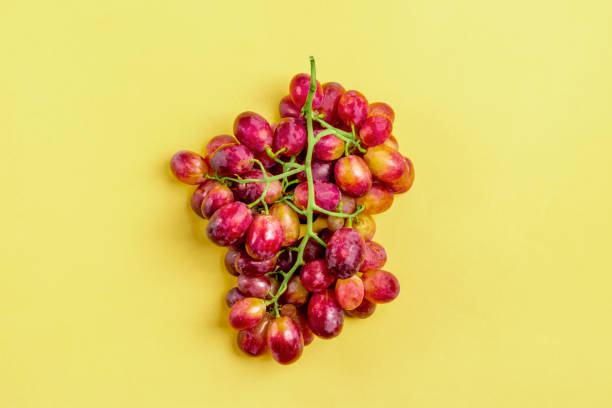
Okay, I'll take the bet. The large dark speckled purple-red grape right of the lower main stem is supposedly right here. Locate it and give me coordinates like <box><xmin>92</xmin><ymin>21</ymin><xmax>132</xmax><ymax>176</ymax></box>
<box><xmin>325</xmin><ymin>228</ymin><xmax>365</xmax><ymax>279</ymax></box>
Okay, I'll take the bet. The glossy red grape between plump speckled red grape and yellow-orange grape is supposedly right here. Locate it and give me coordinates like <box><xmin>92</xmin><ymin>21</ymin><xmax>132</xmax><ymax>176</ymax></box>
<box><xmin>244</xmin><ymin>215</ymin><xmax>285</xmax><ymax>261</ymax></box>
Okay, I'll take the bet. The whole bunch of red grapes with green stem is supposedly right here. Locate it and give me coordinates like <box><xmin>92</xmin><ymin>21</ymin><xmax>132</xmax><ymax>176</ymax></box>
<box><xmin>170</xmin><ymin>57</ymin><xmax>414</xmax><ymax>364</ymax></box>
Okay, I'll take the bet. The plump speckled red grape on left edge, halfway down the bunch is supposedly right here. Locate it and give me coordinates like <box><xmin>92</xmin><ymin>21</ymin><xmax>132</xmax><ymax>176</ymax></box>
<box><xmin>206</xmin><ymin>201</ymin><xmax>253</xmax><ymax>246</ymax></box>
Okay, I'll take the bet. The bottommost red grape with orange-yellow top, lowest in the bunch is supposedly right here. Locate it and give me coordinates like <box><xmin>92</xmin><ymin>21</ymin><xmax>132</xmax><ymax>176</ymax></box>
<box><xmin>266</xmin><ymin>316</ymin><xmax>304</xmax><ymax>364</ymax></box>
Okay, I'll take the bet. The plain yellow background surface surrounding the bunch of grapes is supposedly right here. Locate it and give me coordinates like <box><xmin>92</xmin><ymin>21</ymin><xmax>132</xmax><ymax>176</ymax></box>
<box><xmin>0</xmin><ymin>0</ymin><xmax>612</xmax><ymax>408</ymax></box>
